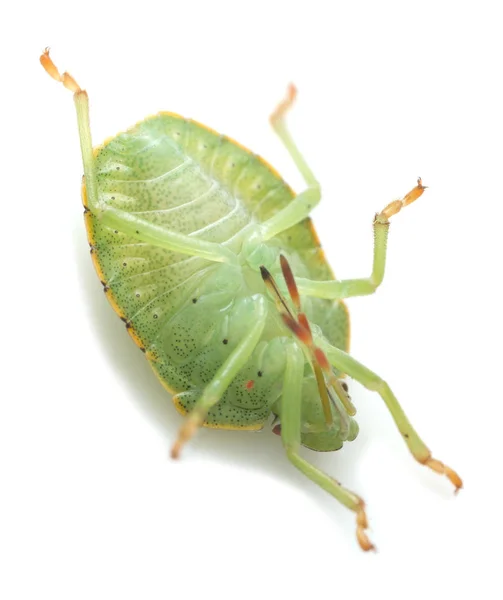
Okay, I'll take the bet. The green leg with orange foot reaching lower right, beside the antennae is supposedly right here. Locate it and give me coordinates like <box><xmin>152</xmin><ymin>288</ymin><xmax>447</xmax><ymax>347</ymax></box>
<box><xmin>318</xmin><ymin>340</ymin><xmax>463</xmax><ymax>492</ymax></box>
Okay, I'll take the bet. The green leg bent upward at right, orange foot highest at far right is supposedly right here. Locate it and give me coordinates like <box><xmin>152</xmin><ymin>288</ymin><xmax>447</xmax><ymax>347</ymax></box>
<box><xmin>297</xmin><ymin>178</ymin><xmax>426</xmax><ymax>300</ymax></box>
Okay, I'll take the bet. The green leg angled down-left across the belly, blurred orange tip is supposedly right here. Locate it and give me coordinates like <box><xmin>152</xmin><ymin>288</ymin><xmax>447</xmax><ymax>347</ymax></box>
<box><xmin>171</xmin><ymin>294</ymin><xmax>267</xmax><ymax>458</ymax></box>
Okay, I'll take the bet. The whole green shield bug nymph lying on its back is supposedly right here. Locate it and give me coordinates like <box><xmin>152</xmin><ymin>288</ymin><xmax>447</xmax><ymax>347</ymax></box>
<box><xmin>40</xmin><ymin>50</ymin><xmax>462</xmax><ymax>550</ymax></box>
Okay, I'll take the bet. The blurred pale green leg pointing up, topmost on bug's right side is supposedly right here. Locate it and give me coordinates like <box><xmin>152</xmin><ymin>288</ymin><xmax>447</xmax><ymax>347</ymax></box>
<box><xmin>261</xmin><ymin>85</ymin><xmax>321</xmax><ymax>241</ymax></box>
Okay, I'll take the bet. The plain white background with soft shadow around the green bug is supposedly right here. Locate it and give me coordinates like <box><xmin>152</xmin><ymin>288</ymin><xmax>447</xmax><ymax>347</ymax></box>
<box><xmin>0</xmin><ymin>0</ymin><xmax>503</xmax><ymax>600</ymax></box>
